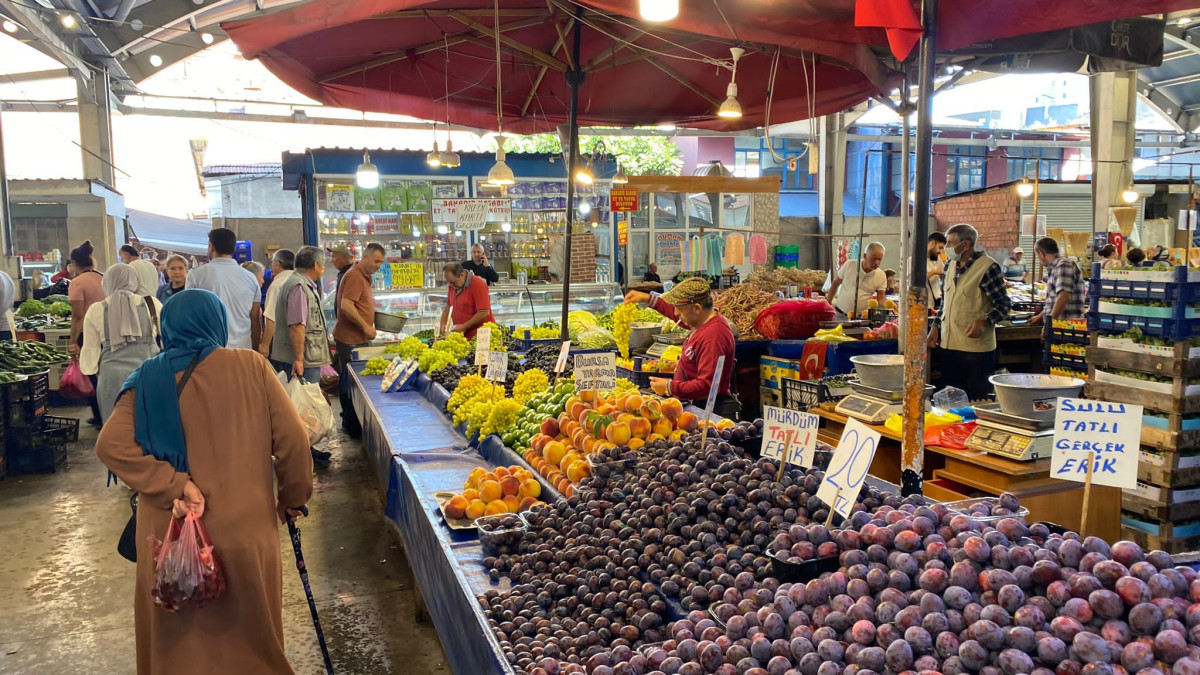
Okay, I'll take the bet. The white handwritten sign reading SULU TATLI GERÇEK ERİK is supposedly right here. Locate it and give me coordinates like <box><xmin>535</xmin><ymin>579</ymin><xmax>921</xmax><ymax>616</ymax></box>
<box><xmin>1050</xmin><ymin>399</ymin><xmax>1142</xmax><ymax>490</ymax></box>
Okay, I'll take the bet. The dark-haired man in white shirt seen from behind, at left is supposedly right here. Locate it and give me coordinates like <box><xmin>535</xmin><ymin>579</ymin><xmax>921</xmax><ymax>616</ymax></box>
<box><xmin>185</xmin><ymin>227</ymin><xmax>263</xmax><ymax>350</ymax></box>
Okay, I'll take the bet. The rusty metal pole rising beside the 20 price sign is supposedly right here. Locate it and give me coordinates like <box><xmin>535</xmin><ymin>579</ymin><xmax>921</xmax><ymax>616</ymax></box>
<box><xmin>900</xmin><ymin>0</ymin><xmax>937</xmax><ymax>495</ymax></box>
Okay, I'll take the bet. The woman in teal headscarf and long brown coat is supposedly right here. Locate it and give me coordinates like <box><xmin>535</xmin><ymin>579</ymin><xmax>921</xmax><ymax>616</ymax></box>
<box><xmin>96</xmin><ymin>289</ymin><xmax>312</xmax><ymax>675</ymax></box>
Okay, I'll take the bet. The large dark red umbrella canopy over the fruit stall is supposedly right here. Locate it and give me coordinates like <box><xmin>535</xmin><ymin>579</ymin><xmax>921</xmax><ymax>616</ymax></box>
<box><xmin>222</xmin><ymin>0</ymin><xmax>895</xmax><ymax>133</ymax></box>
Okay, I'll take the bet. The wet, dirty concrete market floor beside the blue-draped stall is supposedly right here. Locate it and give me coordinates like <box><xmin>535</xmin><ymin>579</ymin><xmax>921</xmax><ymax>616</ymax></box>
<box><xmin>0</xmin><ymin>399</ymin><xmax>450</xmax><ymax>675</ymax></box>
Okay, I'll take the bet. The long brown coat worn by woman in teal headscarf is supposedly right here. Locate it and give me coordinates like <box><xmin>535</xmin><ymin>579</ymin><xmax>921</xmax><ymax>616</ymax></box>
<box><xmin>96</xmin><ymin>348</ymin><xmax>312</xmax><ymax>675</ymax></box>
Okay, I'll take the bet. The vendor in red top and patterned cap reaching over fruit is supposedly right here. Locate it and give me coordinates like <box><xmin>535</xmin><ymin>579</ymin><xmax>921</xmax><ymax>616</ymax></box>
<box><xmin>625</xmin><ymin>277</ymin><xmax>742</xmax><ymax>419</ymax></box>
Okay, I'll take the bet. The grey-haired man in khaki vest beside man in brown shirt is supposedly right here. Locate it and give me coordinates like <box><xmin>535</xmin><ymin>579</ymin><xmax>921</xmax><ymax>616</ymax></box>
<box><xmin>271</xmin><ymin>246</ymin><xmax>331</xmax><ymax>468</ymax></box>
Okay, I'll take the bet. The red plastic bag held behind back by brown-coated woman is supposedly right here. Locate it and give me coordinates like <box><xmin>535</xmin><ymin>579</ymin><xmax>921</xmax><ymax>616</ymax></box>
<box><xmin>150</xmin><ymin>512</ymin><xmax>226</xmax><ymax>611</ymax></box>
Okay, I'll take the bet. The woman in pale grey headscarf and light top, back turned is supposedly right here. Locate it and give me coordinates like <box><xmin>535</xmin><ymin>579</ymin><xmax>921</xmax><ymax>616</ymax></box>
<box><xmin>79</xmin><ymin>262</ymin><xmax>162</xmax><ymax>422</ymax></box>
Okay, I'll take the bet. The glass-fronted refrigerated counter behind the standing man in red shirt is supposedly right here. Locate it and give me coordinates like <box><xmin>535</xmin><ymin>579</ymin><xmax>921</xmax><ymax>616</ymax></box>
<box><xmin>325</xmin><ymin>278</ymin><xmax>622</xmax><ymax>334</ymax></box>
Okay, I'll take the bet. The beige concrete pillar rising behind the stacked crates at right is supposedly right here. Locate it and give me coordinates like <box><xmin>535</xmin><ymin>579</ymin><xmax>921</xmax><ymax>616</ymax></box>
<box><xmin>1088</xmin><ymin>71</ymin><xmax>1138</xmax><ymax>242</ymax></box>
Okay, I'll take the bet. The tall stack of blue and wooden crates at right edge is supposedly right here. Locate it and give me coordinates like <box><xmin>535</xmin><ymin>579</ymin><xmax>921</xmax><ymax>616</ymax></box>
<box><xmin>1087</xmin><ymin>265</ymin><xmax>1200</xmax><ymax>554</ymax></box>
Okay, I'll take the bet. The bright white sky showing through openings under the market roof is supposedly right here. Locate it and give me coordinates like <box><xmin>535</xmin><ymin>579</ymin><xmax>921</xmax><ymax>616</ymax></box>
<box><xmin>0</xmin><ymin>34</ymin><xmax>1170</xmax><ymax>217</ymax></box>
